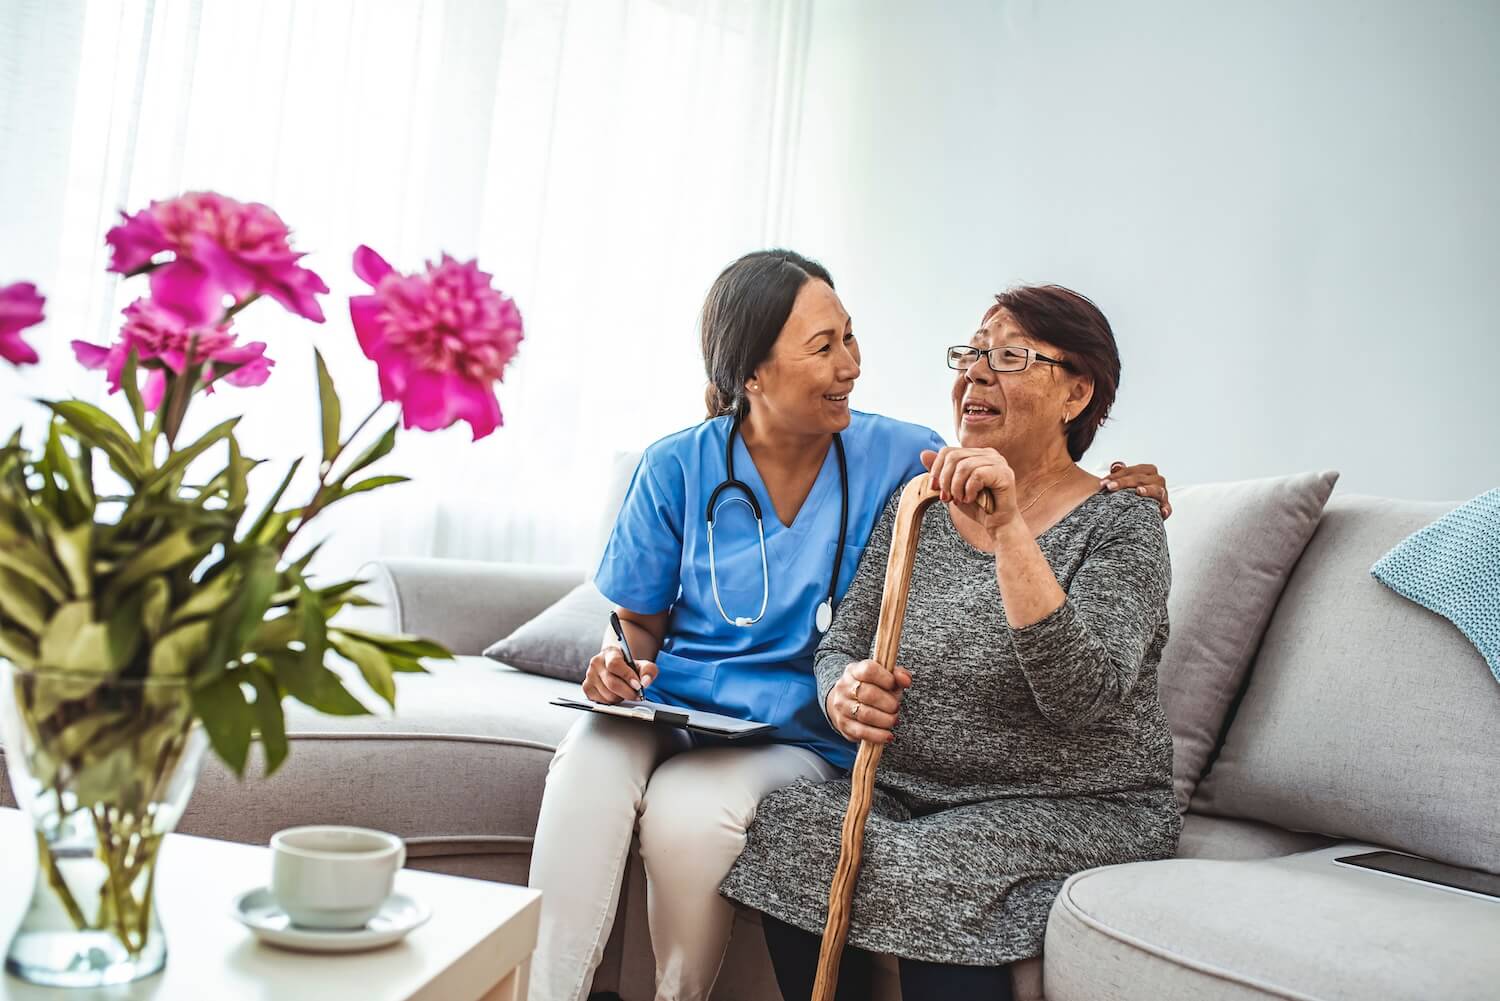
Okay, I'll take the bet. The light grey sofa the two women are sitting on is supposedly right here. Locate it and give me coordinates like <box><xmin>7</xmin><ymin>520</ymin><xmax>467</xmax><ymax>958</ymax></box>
<box><xmin>0</xmin><ymin>491</ymin><xmax>1500</xmax><ymax>1001</ymax></box>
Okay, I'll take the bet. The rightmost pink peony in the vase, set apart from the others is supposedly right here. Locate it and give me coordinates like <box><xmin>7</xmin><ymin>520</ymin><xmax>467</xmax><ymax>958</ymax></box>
<box><xmin>350</xmin><ymin>246</ymin><xmax>522</xmax><ymax>440</ymax></box>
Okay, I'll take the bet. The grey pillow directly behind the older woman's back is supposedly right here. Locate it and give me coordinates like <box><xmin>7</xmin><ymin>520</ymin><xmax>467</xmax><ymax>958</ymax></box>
<box><xmin>1157</xmin><ymin>473</ymin><xmax>1338</xmax><ymax>809</ymax></box>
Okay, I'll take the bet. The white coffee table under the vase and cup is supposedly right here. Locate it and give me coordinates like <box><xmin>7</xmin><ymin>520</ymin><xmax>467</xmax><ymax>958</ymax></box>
<box><xmin>0</xmin><ymin>809</ymin><xmax>542</xmax><ymax>1001</ymax></box>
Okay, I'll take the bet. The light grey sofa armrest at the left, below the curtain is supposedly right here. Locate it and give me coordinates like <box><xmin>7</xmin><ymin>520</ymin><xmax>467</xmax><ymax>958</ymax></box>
<box><xmin>351</xmin><ymin>560</ymin><xmax>584</xmax><ymax>654</ymax></box>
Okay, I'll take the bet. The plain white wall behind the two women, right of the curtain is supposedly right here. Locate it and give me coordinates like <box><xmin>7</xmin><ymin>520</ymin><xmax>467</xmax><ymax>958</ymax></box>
<box><xmin>785</xmin><ymin>0</ymin><xmax>1500</xmax><ymax>498</ymax></box>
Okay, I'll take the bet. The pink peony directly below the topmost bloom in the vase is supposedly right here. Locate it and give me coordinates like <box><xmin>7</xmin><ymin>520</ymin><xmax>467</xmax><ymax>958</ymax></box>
<box><xmin>74</xmin><ymin>299</ymin><xmax>275</xmax><ymax>410</ymax></box>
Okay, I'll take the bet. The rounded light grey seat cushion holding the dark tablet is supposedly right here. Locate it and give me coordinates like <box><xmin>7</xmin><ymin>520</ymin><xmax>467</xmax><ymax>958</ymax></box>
<box><xmin>1043</xmin><ymin>843</ymin><xmax>1500</xmax><ymax>1001</ymax></box>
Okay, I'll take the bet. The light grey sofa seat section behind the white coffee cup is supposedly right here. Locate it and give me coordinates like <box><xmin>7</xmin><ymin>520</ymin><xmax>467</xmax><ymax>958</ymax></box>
<box><xmin>179</xmin><ymin>657</ymin><xmax>578</xmax><ymax>882</ymax></box>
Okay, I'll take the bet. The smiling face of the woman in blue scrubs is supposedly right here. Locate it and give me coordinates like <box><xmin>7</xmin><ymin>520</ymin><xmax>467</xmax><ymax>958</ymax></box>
<box><xmin>746</xmin><ymin>279</ymin><xmax>860</xmax><ymax>434</ymax></box>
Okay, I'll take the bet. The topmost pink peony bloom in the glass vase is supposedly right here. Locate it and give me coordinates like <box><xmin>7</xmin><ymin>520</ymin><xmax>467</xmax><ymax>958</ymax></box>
<box><xmin>105</xmin><ymin>191</ymin><xmax>329</xmax><ymax>326</ymax></box>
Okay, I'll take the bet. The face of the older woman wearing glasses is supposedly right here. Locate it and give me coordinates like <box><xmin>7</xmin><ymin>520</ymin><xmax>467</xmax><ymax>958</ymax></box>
<box><xmin>953</xmin><ymin>308</ymin><xmax>1092</xmax><ymax>465</ymax></box>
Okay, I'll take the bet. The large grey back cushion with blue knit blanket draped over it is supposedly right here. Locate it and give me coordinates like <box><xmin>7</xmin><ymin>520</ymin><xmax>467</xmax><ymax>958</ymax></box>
<box><xmin>1193</xmin><ymin>497</ymin><xmax>1500</xmax><ymax>872</ymax></box>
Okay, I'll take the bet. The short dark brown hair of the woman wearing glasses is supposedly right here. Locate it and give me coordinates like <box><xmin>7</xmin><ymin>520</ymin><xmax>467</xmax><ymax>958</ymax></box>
<box><xmin>984</xmin><ymin>285</ymin><xmax>1121</xmax><ymax>462</ymax></box>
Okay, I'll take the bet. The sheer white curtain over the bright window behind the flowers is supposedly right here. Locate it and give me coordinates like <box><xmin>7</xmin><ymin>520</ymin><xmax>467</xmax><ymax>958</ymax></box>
<box><xmin>0</xmin><ymin>0</ymin><xmax>810</xmax><ymax>572</ymax></box>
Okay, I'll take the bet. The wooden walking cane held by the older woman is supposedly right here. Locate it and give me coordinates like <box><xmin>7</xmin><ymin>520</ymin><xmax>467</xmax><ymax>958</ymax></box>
<box><xmin>813</xmin><ymin>473</ymin><xmax>995</xmax><ymax>1001</ymax></box>
